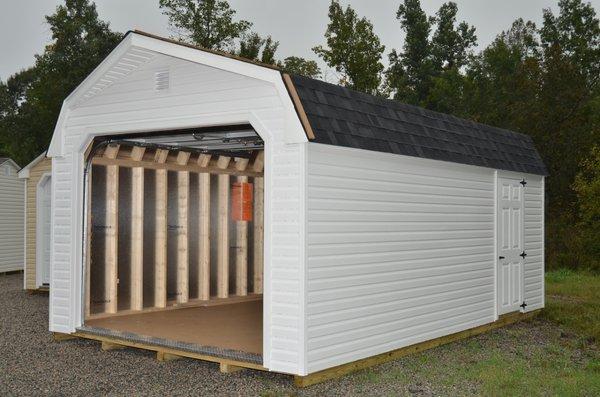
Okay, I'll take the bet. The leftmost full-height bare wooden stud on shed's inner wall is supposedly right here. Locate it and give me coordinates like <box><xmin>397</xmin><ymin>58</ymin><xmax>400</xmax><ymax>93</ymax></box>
<box><xmin>104</xmin><ymin>162</ymin><xmax>119</xmax><ymax>313</ymax></box>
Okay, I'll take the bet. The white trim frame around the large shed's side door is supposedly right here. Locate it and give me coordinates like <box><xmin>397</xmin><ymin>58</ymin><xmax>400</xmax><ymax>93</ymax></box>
<box><xmin>494</xmin><ymin>171</ymin><xmax>527</xmax><ymax>319</ymax></box>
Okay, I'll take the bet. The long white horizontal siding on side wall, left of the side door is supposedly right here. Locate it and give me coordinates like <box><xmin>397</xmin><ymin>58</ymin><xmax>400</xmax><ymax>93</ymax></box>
<box><xmin>306</xmin><ymin>144</ymin><xmax>495</xmax><ymax>372</ymax></box>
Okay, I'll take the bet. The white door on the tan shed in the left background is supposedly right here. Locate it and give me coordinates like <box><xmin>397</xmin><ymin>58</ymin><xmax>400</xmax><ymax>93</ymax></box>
<box><xmin>37</xmin><ymin>177</ymin><xmax>52</xmax><ymax>285</ymax></box>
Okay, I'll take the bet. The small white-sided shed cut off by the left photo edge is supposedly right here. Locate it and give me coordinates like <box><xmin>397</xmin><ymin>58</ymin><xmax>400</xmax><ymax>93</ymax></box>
<box><xmin>0</xmin><ymin>157</ymin><xmax>25</xmax><ymax>273</ymax></box>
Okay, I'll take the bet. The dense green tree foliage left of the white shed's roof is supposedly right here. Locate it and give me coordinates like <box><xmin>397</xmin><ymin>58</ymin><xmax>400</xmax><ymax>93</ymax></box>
<box><xmin>0</xmin><ymin>0</ymin><xmax>121</xmax><ymax>165</ymax></box>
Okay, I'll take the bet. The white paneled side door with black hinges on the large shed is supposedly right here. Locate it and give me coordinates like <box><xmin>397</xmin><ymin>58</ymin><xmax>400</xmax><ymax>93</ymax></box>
<box><xmin>498</xmin><ymin>177</ymin><xmax>525</xmax><ymax>314</ymax></box>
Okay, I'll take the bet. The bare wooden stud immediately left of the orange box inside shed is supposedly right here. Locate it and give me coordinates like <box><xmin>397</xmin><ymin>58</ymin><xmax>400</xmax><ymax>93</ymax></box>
<box><xmin>217</xmin><ymin>174</ymin><xmax>229</xmax><ymax>298</ymax></box>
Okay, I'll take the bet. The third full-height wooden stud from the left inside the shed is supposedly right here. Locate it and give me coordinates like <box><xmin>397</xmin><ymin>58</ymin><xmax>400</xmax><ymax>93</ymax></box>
<box><xmin>154</xmin><ymin>170</ymin><xmax>167</xmax><ymax>308</ymax></box>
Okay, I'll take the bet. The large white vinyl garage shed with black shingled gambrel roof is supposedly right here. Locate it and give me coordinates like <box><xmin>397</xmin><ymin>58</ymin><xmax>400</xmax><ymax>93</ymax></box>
<box><xmin>48</xmin><ymin>32</ymin><xmax>546</xmax><ymax>384</ymax></box>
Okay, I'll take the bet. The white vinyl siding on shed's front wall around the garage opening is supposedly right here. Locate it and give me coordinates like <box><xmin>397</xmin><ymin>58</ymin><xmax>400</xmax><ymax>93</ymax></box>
<box><xmin>51</xmin><ymin>47</ymin><xmax>304</xmax><ymax>373</ymax></box>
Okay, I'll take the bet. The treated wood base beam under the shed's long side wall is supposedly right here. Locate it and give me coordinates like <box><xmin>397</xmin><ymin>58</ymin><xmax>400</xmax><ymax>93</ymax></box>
<box><xmin>294</xmin><ymin>310</ymin><xmax>541</xmax><ymax>387</ymax></box>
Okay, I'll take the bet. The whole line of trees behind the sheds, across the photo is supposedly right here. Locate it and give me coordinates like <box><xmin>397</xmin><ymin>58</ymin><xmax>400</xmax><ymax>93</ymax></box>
<box><xmin>0</xmin><ymin>0</ymin><xmax>600</xmax><ymax>271</ymax></box>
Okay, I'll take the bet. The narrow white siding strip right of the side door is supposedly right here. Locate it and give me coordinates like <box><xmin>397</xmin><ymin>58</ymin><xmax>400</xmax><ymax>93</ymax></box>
<box><xmin>524</xmin><ymin>175</ymin><xmax>544</xmax><ymax>311</ymax></box>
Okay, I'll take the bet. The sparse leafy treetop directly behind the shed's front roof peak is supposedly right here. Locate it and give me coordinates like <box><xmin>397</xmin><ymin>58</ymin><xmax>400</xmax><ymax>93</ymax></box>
<box><xmin>159</xmin><ymin>0</ymin><xmax>252</xmax><ymax>51</ymax></box>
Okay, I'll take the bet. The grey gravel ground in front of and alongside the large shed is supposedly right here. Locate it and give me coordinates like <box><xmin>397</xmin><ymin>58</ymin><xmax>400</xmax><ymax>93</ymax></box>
<box><xmin>0</xmin><ymin>274</ymin><xmax>596</xmax><ymax>396</ymax></box>
